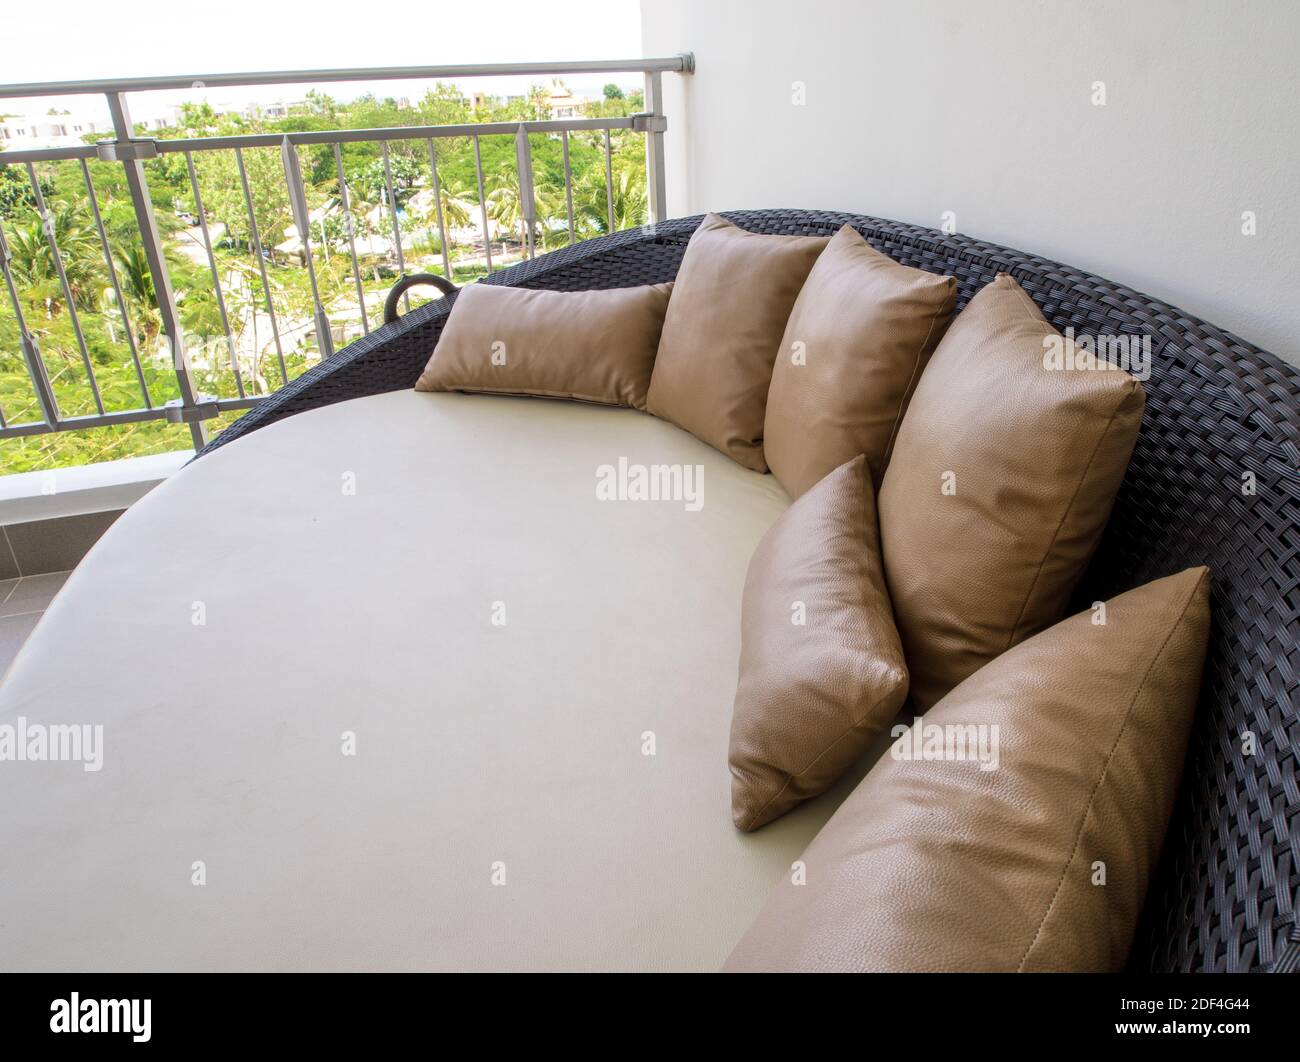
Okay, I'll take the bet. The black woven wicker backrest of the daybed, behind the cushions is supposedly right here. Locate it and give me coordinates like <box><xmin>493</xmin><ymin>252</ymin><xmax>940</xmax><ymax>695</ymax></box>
<box><xmin>203</xmin><ymin>211</ymin><xmax>1300</xmax><ymax>971</ymax></box>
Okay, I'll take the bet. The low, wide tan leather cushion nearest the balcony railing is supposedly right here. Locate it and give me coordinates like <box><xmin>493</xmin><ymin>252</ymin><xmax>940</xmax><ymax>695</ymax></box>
<box><xmin>415</xmin><ymin>283</ymin><xmax>672</xmax><ymax>409</ymax></box>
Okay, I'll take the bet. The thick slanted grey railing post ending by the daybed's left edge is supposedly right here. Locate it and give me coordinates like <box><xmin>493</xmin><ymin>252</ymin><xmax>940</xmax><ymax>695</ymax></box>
<box><xmin>100</xmin><ymin>92</ymin><xmax>216</xmax><ymax>450</ymax></box>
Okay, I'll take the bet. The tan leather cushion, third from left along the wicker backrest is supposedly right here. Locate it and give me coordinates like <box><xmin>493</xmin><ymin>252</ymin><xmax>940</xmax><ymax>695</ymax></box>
<box><xmin>763</xmin><ymin>225</ymin><xmax>957</xmax><ymax>498</ymax></box>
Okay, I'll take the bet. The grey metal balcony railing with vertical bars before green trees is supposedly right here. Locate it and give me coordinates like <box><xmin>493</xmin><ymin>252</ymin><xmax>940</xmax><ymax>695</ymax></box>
<box><xmin>0</xmin><ymin>55</ymin><xmax>694</xmax><ymax>447</ymax></box>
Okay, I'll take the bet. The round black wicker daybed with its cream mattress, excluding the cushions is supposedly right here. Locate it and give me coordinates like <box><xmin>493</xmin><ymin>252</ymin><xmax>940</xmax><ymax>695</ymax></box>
<box><xmin>0</xmin><ymin>211</ymin><xmax>1300</xmax><ymax>971</ymax></box>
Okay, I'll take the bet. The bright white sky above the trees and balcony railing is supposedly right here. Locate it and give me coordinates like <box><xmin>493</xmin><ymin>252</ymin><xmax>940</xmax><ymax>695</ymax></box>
<box><xmin>0</xmin><ymin>0</ymin><xmax>641</xmax><ymax>118</ymax></box>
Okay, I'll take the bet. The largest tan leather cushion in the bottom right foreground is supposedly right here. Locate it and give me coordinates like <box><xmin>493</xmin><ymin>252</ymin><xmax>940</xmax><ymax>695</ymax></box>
<box><xmin>727</xmin><ymin>568</ymin><xmax>1209</xmax><ymax>971</ymax></box>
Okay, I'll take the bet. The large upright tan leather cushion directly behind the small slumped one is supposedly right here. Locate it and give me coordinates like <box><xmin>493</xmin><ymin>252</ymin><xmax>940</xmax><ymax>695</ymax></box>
<box><xmin>878</xmin><ymin>276</ymin><xmax>1144</xmax><ymax>708</ymax></box>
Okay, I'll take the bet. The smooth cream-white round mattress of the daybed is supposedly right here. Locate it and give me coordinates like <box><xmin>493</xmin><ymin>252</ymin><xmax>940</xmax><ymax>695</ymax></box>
<box><xmin>0</xmin><ymin>393</ymin><xmax>883</xmax><ymax>970</ymax></box>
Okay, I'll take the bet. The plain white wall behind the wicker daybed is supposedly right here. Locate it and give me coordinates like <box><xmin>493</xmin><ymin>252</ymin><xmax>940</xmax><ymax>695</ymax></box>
<box><xmin>641</xmin><ymin>0</ymin><xmax>1300</xmax><ymax>363</ymax></box>
